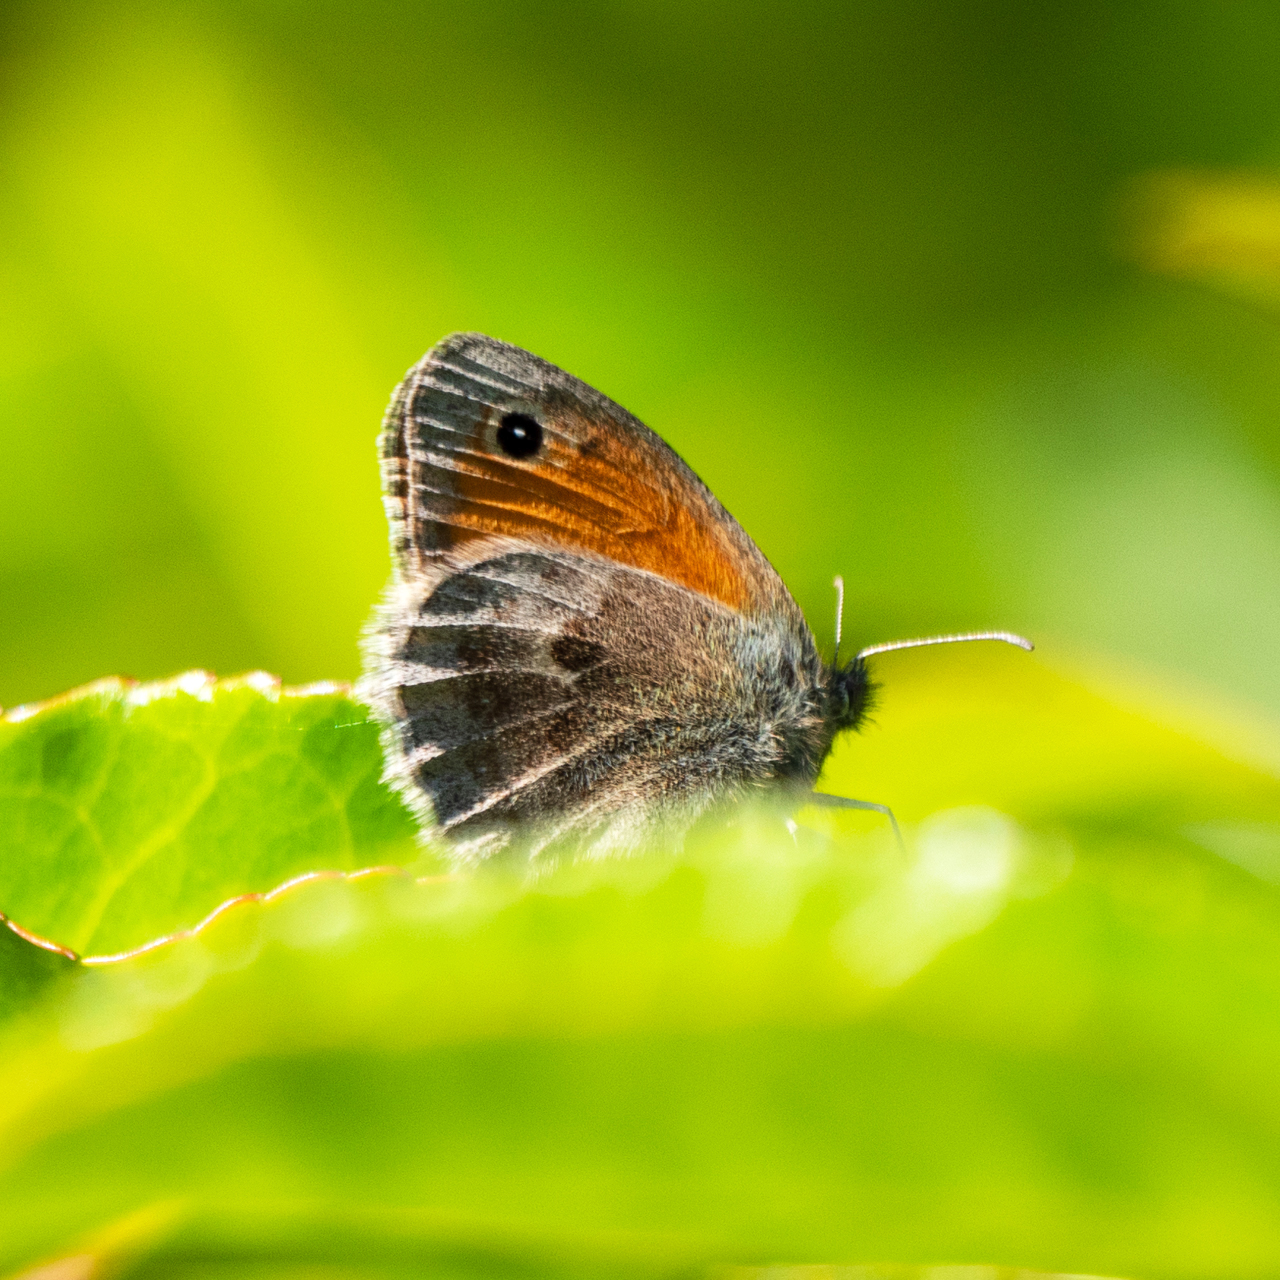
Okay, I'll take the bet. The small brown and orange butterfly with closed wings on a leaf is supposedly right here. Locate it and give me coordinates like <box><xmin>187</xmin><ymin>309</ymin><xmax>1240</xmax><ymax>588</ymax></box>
<box><xmin>360</xmin><ymin>333</ymin><xmax>1029</xmax><ymax>861</ymax></box>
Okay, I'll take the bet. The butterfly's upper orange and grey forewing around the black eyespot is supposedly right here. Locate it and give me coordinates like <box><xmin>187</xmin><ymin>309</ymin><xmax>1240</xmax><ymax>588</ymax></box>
<box><xmin>383</xmin><ymin>334</ymin><xmax>799</xmax><ymax>618</ymax></box>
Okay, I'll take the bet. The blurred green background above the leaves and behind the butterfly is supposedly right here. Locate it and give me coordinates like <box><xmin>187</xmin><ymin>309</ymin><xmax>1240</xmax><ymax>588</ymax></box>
<box><xmin>0</xmin><ymin>0</ymin><xmax>1280</xmax><ymax>713</ymax></box>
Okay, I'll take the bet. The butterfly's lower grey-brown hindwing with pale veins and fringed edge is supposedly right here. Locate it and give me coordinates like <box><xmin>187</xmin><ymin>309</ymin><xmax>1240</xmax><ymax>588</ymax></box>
<box><xmin>366</xmin><ymin>548</ymin><xmax>808</xmax><ymax>855</ymax></box>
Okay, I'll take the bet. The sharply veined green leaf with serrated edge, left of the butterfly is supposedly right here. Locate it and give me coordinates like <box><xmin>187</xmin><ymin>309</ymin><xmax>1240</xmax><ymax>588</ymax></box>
<box><xmin>0</xmin><ymin>672</ymin><xmax>421</xmax><ymax>955</ymax></box>
